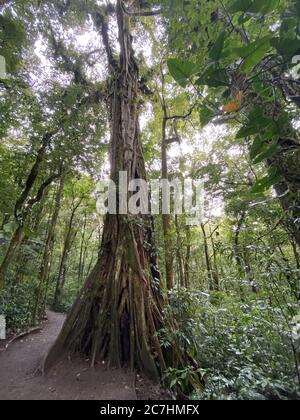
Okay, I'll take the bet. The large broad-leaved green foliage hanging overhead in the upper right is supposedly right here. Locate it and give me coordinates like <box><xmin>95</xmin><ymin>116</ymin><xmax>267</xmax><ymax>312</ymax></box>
<box><xmin>165</xmin><ymin>0</ymin><xmax>300</xmax><ymax>195</ymax></box>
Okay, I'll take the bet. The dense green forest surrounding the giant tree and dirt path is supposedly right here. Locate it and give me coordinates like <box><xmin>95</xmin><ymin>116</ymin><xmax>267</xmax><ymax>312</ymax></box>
<box><xmin>0</xmin><ymin>0</ymin><xmax>300</xmax><ymax>399</ymax></box>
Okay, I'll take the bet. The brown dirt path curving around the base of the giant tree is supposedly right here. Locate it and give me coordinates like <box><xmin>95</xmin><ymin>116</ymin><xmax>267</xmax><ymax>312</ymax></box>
<box><xmin>0</xmin><ymin>312</ymin><xmax>136</xmax><ymax>400</ymax></box>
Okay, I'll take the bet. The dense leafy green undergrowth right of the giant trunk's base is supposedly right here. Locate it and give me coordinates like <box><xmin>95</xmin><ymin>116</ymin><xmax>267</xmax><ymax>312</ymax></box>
<box><xmin>162</xmin><ymin>289</ymin><xmax>300</xmax><ymax>400</ymax></box>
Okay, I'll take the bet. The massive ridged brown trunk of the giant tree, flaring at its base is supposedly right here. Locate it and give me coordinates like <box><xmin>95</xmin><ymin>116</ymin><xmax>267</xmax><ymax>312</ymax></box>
<box><xmin>44</xmin><ymin>1</ymin><xmax>173</xmax><ymax>379</ymax></box>
